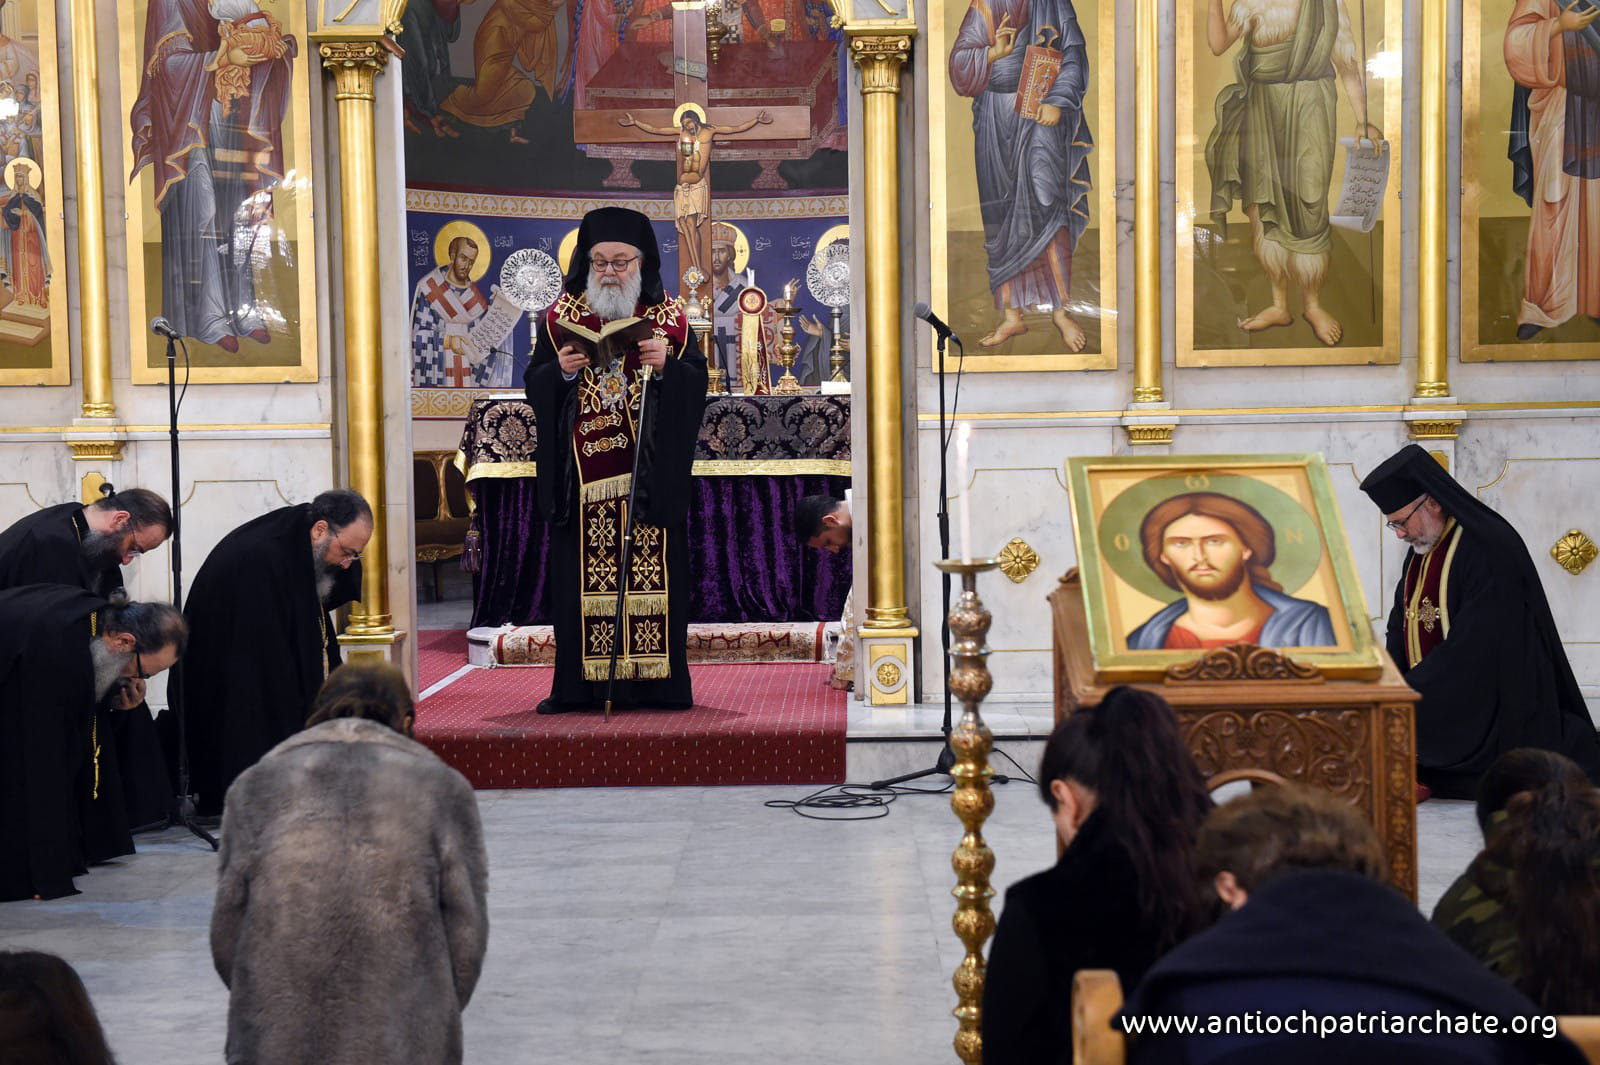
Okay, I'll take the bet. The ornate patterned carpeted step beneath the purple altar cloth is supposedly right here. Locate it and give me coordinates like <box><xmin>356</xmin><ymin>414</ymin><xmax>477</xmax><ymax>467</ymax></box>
<box><xmin>467</xmin><ymin>620</ymin><xmax>840</xmax><ymax>665</ymax></box>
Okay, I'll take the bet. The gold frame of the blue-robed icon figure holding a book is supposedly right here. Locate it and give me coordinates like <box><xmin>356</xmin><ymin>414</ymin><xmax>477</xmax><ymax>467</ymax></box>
<box><xmin>925</xmin><ymin>0</ymin><xmax>1117</xmax><ymax>373</ymax></box>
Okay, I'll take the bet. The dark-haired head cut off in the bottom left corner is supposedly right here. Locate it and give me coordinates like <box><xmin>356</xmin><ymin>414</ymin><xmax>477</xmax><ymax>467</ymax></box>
<box><xmin>0</xmin><ymin>950</ymin><xmax>114</xmax><ymax>1065</ymax></box>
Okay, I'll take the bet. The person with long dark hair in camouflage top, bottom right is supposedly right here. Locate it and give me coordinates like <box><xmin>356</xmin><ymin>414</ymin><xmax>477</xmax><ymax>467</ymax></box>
<box><xmin>1434</xmin><ymin>750</ymin><xmax>1600</xmax><ymax>1014</ymax></box>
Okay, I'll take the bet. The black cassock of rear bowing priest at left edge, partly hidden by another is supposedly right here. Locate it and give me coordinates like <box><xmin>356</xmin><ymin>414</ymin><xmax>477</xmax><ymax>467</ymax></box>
<box><xmin>0</xmin><ymin>504</ymin><xmax>174</xmax><ymax>827</ymax></box>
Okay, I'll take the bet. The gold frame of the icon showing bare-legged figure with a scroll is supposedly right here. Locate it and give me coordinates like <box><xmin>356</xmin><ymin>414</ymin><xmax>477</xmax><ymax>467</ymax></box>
<box><xmin>1174</xmin><ymin>0</ymin><xmax>1401</xmax><ymax>366</ymax></box>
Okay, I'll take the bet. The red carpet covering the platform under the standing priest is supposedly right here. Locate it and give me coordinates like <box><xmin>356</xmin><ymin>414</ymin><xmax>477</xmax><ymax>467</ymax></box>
<box><xmin>416</xmin><ymin>664</ymin><xmax>846</xmax><ymax>788</ymax></box>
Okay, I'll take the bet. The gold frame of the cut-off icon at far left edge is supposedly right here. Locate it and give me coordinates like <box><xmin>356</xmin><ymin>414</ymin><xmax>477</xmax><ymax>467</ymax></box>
<box><xmin>0</xmin><ymin>0</ymin><xmax>72</xmax><ymax>385</ymax></box>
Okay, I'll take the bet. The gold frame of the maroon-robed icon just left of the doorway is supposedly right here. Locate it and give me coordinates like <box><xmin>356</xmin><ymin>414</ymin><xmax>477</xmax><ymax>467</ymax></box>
<box><xmin>117</xmin><ymin>0</ymin><xmax>322</xmax><ymax>384</ymax></box>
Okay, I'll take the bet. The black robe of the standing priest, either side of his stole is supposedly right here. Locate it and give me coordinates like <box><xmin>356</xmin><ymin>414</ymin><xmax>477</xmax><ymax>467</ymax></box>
<box><xmin>523</xmin><ymin>319</ymin><xmax>706</xmax><ymax>708</ymax></box>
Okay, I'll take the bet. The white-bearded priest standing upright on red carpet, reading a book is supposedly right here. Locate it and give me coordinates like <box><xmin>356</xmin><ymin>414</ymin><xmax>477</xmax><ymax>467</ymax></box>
<box><xmin>523</xmin><ymin>206</ymin><xmax>706</xmax><ymax>713</ymax></box>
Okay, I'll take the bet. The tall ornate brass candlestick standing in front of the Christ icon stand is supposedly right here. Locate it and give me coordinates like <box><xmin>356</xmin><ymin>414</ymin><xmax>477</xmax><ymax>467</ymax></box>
<box><xmin>933</xmin><ymin>558</ymin><xmax>1000</xmax><ymax>1065</ymax></box>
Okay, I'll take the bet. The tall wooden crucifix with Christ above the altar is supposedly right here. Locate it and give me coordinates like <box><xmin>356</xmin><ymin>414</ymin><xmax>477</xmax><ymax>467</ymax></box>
<box><xmin>573</xmin><ymin>0</ymin><xmax>811</xmax><ymax>299</ymax></box>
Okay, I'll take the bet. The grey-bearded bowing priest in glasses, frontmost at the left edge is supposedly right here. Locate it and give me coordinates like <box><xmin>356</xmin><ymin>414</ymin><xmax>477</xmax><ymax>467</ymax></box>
<box><xmin>0</xmin><ymin>584</ymin><xmax>187</xmax><ymax>902</ymax></box>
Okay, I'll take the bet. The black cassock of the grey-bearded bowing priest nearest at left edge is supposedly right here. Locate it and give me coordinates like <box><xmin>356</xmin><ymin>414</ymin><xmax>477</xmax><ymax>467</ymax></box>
<box><xmin>0</xmin><ymin>584</ymin><xmax>149</xmax><ymax>900</ymax></box>
